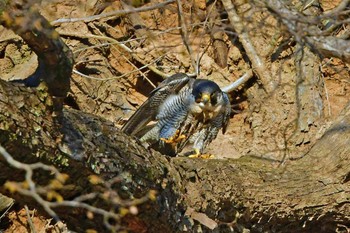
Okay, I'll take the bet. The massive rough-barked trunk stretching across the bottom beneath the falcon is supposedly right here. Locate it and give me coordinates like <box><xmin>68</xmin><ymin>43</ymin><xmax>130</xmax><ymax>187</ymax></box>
<box><xmin>0</xmin><ymin>78</ymin><xmax>350</xmax><ymax>232</ymax></box>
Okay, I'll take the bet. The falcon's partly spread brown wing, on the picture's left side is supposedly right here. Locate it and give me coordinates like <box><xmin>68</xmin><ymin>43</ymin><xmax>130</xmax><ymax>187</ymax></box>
<box><xmin>122</xmin><ymin>73</ymin><xmax>191</xmax><ymax>135</ymax></box>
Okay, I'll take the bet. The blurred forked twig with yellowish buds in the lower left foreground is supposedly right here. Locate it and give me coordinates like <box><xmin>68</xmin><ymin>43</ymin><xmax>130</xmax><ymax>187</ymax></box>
<box><xmin>0</xmin><ymin>145</ymin><xmax>154</xmax><ymax>230</ymax></box>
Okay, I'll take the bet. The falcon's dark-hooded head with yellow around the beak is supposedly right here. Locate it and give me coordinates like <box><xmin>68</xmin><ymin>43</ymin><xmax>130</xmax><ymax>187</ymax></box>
<box><xmin>192</xmin><ymin>79</ymin><xmax>222</xmax><ymax>107</ymax></box>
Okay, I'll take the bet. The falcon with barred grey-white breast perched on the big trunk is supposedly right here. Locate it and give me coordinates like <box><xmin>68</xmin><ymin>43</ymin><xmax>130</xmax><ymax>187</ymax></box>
<box><xmin>122</xmin><ymin>73</ymin><xmax>231</xmax><ymax>157</ymax></box>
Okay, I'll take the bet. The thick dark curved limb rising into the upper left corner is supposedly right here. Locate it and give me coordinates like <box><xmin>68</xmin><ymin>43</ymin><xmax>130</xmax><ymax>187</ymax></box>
<box><xmin>0</xmin><ymin>0</ymin><xmax>74</xmax><ymax>99</ymax></box>
